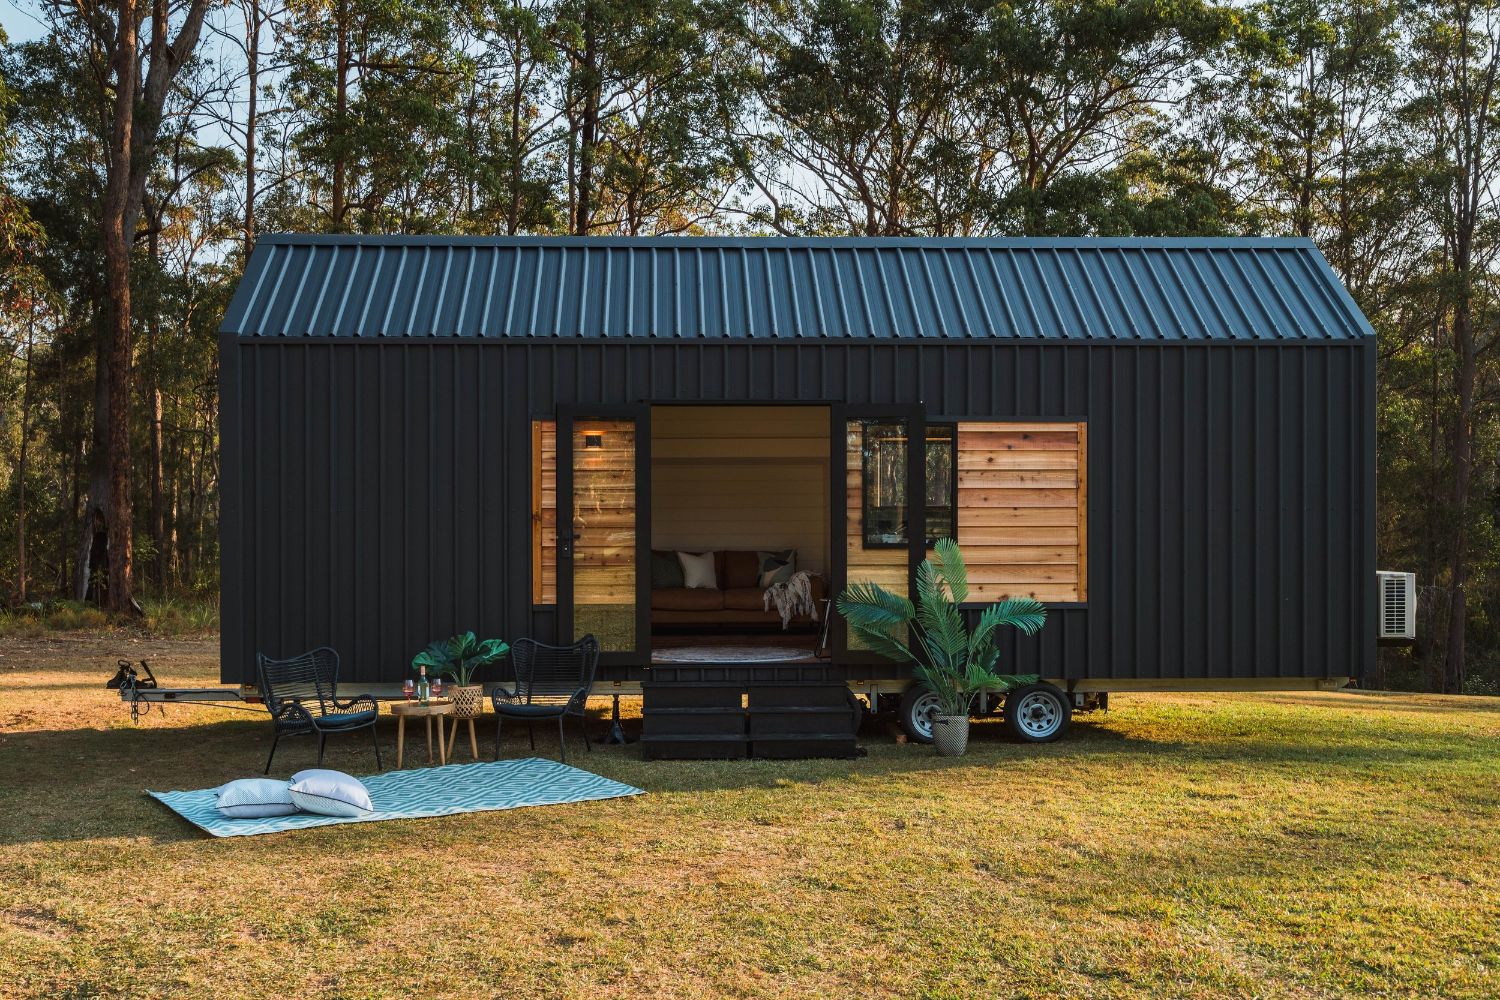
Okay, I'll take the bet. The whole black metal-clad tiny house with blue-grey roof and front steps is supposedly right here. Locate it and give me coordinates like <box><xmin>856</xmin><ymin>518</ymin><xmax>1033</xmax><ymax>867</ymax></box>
<box><xmin>221</xmin><ymin>235</ymin><xmax>1377</xmax><ymax>756</ymax></box>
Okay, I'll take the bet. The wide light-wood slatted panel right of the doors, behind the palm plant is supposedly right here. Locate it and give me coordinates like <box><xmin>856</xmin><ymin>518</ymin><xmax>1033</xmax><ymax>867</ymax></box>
<box><xmin>959</xmin><ymin>421</ymin><xmax>1088</xmax><ymax>601</ymax></box>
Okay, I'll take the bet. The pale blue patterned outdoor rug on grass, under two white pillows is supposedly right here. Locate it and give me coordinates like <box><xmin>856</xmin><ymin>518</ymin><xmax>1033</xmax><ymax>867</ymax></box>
<box><xmin>147</xmin><ymin>757</ymin><xmax>645</xmax><ymax>837</ymax></box>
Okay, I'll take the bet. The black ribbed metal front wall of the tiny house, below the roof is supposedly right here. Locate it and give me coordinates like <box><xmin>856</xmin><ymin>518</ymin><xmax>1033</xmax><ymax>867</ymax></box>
<box><xmin>222</xmin><ymin>336</ymin><xmax>1376</xmax><ymax>682</ymax></box>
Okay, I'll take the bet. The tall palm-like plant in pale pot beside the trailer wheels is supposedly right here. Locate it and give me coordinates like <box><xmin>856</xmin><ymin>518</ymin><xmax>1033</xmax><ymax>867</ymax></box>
<box><xmin>837</xmin><ymin>538</ymin><xmax>1047</xmax><ymax>757</ymax></box>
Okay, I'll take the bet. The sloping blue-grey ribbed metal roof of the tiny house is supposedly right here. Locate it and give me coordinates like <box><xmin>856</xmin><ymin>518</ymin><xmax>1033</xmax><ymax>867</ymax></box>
<box><xmin>222</xmin><ymin>235</ymin><xmax>1374</xmax><ymax>340</ymax></box>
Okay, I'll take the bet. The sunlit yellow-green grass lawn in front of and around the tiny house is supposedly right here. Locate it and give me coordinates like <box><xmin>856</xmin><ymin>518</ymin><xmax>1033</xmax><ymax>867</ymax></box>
<box><xmin>0</xmin><ymin>636</ymin><xmax>1500</xmax><ymax>1000</ymax></box>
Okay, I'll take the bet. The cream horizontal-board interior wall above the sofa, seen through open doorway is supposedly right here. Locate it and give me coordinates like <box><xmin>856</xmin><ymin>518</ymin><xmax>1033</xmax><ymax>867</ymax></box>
<box><xmin>651</xmin><ymin>406</ymin><xmax>830</xmax><ymax>573</ymax></box>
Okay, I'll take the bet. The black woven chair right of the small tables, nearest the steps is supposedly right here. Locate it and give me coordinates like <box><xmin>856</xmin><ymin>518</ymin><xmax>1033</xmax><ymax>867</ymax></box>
<box><xmin>491</xmin><ymin>636</ymin><xmax>599</xmax><ymax>763</ymax></box>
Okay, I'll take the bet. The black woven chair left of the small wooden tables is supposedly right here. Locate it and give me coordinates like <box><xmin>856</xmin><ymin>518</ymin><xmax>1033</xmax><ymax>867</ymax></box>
<box><xmin>255</xmin><ymin>646</ymin><xmax>381</xmax><ymax>774</ymax></box>
